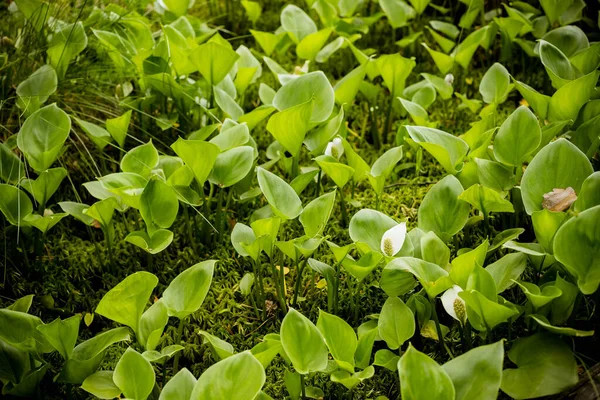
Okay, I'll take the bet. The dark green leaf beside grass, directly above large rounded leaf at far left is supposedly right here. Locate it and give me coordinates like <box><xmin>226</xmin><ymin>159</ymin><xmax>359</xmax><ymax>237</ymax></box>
<box><xmin>17</xmin><ymin>64</ymin><xmax>58</xmax><ymax>115</ymax></box>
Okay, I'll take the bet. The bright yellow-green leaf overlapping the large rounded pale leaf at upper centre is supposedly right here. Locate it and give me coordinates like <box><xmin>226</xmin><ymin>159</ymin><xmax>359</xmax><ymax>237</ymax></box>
<box><xmin>267</xmin><ymin>100</ymin><xmax>314</xmax><ymax>157</ymax></box>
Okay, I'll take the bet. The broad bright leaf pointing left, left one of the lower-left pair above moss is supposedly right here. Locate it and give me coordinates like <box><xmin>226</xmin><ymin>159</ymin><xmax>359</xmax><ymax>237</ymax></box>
<box><xmin>95</xmin><ymin>271</ymin><xmax>158</xmax><ymax>335</ymax></box>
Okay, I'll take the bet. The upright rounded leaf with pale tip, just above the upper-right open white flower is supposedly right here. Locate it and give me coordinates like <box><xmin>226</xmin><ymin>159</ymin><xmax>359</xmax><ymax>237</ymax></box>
<box><xmin>418</xmin><ymin>175</ymin><xmax>470</xmax><ymax>239</ymax></box>
